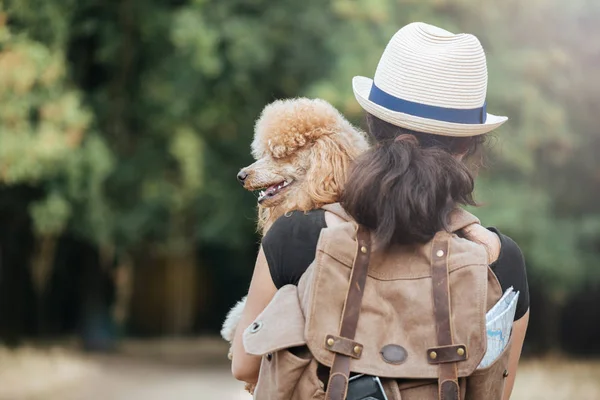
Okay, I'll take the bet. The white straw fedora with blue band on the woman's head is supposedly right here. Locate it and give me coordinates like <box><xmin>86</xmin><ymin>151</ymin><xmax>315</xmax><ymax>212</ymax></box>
<box><xmin>352</xmin><ymin>22</ymin><xmax>508</xmax><ymax>136</ymax></box>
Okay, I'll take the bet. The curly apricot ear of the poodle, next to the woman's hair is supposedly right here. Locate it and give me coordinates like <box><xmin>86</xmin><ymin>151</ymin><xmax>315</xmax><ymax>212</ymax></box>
<box><xmin>306</xmin><ymin>135</ymin><xmax>356</xmax><ymax>208</ymax></box>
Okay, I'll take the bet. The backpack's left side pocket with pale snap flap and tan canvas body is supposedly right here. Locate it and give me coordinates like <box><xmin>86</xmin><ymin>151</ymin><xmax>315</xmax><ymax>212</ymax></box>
<box><xmin>244</xmin><ymin>285</ymin><xmax>324</xmax><ymax>400</ymax></box>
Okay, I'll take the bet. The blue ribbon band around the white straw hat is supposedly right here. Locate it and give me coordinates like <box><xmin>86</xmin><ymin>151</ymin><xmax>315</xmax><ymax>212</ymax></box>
<box><xmin>369</xmin><ymin>82</ymin><xmax>487</xmax><ymax>124</ymax></box>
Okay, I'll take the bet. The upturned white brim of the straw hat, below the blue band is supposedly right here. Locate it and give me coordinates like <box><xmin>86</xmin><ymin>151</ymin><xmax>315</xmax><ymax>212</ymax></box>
<box><xmin>352</xmin><ymin>76</ymin><xmax>508</xmax><ymax>137</ymax></box>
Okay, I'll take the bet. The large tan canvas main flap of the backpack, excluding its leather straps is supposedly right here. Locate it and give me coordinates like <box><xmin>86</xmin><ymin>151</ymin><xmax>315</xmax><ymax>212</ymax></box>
<box><xmin>301</xmin><ymin>224</ymin><xmax>500</xmax><ymax>379</ymax></box>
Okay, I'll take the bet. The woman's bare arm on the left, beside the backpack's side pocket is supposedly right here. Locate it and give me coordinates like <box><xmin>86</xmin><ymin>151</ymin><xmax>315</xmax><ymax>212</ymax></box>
<box><xmin>231</xmin><ymin>247</ymin><xmax>277</xmax><ymax>383</ymax></box>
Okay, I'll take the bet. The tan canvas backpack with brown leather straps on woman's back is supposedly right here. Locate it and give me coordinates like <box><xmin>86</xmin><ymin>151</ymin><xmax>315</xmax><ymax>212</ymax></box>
<box><xmin>244</xmin><ymin>204</ymin><xmax>510</xmax><ymax>400</ymax></box>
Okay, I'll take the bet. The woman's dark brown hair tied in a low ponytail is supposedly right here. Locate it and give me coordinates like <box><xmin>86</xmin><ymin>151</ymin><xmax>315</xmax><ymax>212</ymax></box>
<box><xmin>341</xmin><ymin>114</ymin><xmax>484</xmax><ymax>247</ymax></box>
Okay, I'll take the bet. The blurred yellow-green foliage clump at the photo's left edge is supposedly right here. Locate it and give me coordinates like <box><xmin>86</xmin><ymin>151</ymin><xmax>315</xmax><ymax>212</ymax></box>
<box><xmin>0</xmin><ymin>6</ymin><xmax>113</xmax><ymax>243</ymax></box>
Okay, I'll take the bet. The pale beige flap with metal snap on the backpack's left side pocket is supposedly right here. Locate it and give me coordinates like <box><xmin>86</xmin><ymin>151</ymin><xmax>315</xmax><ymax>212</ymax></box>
<box><xmin>243</xmin><ymin>285</ymin><xmax>306</xmax><ymax>356</ymax></box>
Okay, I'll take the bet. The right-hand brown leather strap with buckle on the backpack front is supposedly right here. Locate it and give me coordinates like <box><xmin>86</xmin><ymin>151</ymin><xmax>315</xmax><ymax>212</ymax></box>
<box><xmin>427</xmin><ymin>233</ymin><xmax>467</xmax><ymax>400</ymax></box>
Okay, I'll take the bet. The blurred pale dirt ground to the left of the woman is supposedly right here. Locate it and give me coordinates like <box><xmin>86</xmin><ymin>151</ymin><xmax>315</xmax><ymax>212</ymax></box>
<box><xmin>0</xmin><ymin>338</ymin><xmax>251</xmax><ymax>400</ymax></box>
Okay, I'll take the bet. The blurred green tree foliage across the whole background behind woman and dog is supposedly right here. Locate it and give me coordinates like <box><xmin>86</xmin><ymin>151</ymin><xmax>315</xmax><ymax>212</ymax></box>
<box><xmin>0</xmin><ymin>0</ymin><xmax>600</xmax><ymax>338</ymax></box>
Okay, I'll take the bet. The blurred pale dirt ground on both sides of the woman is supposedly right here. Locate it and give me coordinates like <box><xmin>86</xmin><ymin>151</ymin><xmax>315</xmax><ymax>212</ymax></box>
<box><xmin>7</xmin><ymin>340</ymin><xmax>600</xmax><ymax>400</ymax></box>
